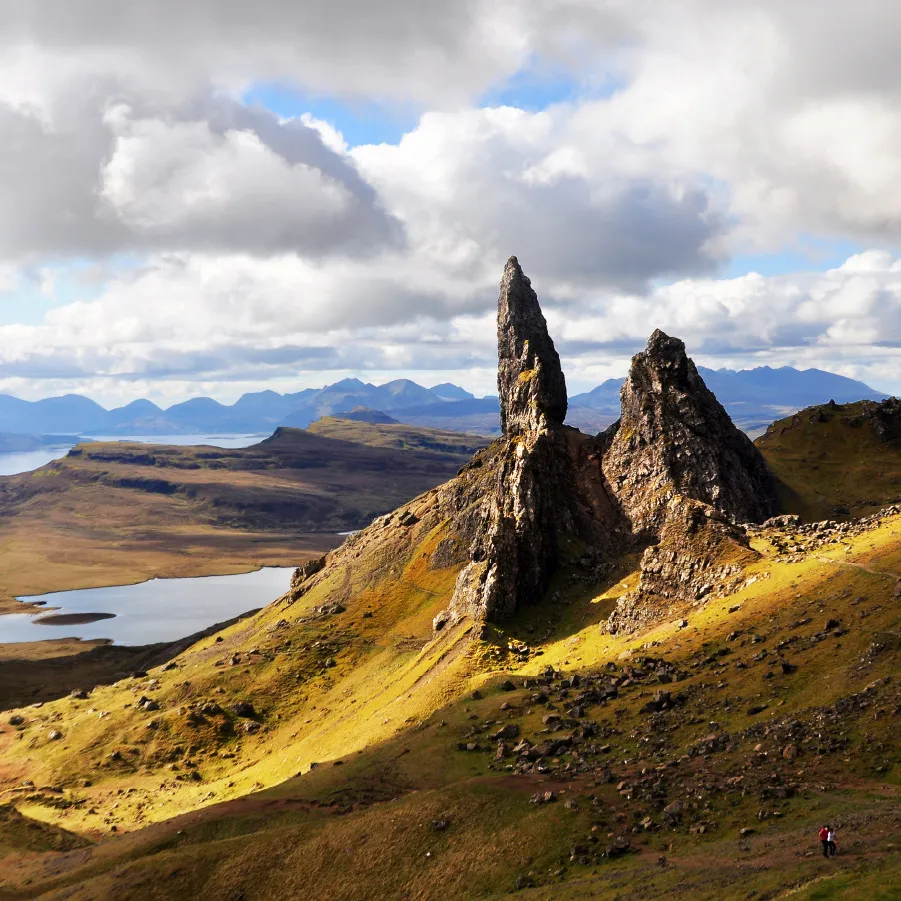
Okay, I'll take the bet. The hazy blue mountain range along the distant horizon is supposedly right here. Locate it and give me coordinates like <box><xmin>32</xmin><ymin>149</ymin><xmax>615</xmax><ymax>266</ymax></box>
<box><xmin>0</xmin><ymin>366</ymin><xmax>887</xmax><ymax>435</ymax></box>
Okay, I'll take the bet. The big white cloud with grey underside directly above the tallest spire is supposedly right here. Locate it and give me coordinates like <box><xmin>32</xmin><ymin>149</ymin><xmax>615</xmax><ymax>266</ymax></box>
<box><xmin>353</xmin><ymin>106</ymin><xmax>726</xmax><ymax>290</ymax></box>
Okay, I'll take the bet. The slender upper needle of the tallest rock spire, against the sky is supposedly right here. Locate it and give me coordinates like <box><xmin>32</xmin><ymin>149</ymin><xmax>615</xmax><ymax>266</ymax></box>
<box><xmin>497</xmin><ymin>257</ymin><xmax>567</xmax><ymax>438</ymax></box>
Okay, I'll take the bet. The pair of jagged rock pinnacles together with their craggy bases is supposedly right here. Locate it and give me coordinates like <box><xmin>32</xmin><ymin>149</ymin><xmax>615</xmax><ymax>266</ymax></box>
<box><xmin>436</xmin><ymin>257</ymin><xmax>777</xmax><ymax>630</ymax></box>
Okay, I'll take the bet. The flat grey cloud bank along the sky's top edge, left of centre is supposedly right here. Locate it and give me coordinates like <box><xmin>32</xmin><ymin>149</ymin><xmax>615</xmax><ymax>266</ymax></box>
<box><xmin>0</xmin><ymin>0</ymin><xmax>528</xmax><ymax>103</ymax></box>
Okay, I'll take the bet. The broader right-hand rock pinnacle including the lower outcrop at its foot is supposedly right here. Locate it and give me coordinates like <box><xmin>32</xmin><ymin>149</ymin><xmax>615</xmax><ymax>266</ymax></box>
<box><xmin>602</xmin><ymin>329</ymin><xmax>779</xmax><ymax>632</ymax></box>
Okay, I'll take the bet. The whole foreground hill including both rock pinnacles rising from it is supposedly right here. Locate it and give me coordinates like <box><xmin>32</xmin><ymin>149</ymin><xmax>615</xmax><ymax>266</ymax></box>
<box><xmin>0</xmin><ymin>259</ymin><xmax>901</xmax><ymax>901</ymax></box>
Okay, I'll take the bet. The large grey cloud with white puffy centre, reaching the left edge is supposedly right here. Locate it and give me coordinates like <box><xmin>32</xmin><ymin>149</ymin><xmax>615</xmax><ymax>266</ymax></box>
<box><xmin>0</xmin><ymin>85</ymin><xmax>403</xmax><ymax>262</ymax></box>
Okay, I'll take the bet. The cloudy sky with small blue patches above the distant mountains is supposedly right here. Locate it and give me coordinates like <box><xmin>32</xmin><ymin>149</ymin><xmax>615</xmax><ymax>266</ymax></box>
<box><xmin>0</xmin><ymin>0</ymin><xmax>901</xmax><ymax>406</ymax></box>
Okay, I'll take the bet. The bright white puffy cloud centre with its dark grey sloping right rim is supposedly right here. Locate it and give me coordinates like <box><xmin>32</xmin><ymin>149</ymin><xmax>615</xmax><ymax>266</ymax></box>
<box><xmin>99</xmin><ymin>103</ymin><xmax>402</xmax><ymax>256</ymax></box>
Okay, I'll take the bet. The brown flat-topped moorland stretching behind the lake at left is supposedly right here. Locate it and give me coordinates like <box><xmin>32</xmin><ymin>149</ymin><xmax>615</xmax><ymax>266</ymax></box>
<box><xmin>0</xmin><ymin>426</ymin><xmax>472</xmax><ymax>616</ymax></box>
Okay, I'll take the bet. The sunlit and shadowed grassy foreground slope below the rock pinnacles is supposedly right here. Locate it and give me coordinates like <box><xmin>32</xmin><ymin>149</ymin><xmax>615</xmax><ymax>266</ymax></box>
<box><xmin>0</xmin><ymin>467</ymin><xmax>901</xmax><ymax>901</ymax></box>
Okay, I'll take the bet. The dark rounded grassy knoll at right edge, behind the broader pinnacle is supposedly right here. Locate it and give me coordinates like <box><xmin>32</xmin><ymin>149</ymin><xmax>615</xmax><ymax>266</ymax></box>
<box><xmin>755</xmin><ymin>401</ymin><xmax>901</xmax><ymax>521</ymax></box>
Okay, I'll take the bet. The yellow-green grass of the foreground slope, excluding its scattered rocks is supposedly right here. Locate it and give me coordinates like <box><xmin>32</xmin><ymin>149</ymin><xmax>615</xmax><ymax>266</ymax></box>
<box><xmin>0</xmin><ymin>496</ymin><xmax>901</xmax><ymax>899</ymax></box>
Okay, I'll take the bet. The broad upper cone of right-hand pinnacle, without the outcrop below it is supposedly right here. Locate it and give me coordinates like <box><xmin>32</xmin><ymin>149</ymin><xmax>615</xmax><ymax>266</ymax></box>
<box><xmin>603</xmin><ymin>329</ymin><xmax>778</xmax><ymax>534</ymax></box>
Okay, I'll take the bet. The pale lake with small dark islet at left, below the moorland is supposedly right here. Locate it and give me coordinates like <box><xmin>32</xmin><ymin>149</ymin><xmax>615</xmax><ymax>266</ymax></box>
<box><xmin>0</xmin><ymin>567</ymin><xmax>294</xmax><ymax>645</ymax></box>
